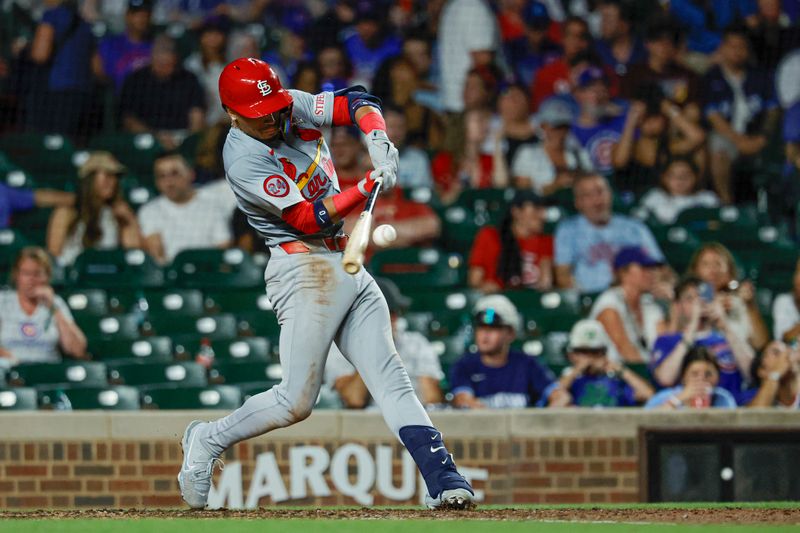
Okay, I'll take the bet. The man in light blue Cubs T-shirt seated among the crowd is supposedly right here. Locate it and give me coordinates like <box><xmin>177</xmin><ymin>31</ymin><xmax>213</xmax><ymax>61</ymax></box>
<box><xmin>555</xmin><ymin>174</ymin><xmax>664</xmax><ymax>293</ymax></box>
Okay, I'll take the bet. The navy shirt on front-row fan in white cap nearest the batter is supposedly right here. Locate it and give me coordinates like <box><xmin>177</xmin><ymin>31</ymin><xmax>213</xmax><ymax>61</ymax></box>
<box><xmin>450</xmin><ymin>350</ymin><xmax>555</xmax><ymax>409</ymax></box>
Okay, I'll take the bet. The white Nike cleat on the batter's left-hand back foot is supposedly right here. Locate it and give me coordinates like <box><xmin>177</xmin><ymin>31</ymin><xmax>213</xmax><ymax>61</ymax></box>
<box><xmin>178</xmin><ymin>420</ymin><xmax>224</xmax><ymax>509</ymax></box>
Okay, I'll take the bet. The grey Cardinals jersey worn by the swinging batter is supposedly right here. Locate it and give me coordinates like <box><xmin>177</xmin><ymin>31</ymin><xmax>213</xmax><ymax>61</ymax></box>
<box><xmin>222</xmin><ymin>90</ymin><xmax>341</xmax><ymax>246</ymax></box>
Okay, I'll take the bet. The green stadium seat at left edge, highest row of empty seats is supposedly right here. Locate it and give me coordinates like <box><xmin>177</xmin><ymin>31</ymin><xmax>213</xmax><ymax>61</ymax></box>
<box><xmin>0</xmin><ymin>133</ymin><xmax>77</xmax><ymax>174</ymax></box>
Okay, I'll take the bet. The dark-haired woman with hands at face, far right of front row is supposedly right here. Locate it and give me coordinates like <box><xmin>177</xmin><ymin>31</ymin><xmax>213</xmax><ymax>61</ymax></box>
<box><xmin>746</xmin><ymin>341</ymin><xmax>800</xmax><ymax>409</ymax></box>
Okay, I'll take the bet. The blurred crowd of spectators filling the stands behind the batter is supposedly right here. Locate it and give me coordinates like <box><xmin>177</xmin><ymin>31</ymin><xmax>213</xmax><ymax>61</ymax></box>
<box><xmin>0</xmin><ymin>0</ymin><xmax>800</xmax><ymax>408</ymax></box>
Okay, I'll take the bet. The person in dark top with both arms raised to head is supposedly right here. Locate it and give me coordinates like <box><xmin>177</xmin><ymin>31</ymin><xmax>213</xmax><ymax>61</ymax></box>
<box><xmin>611</xmin><ymin>85</ymin><xmax>706</xmax><ymax>195</ymax></box>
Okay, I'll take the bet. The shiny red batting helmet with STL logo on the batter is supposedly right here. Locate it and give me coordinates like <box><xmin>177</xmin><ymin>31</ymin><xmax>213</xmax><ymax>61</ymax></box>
<box><xmin>219</xmin><ymin>57</ymin><xmax>292</xmax><ymax>118</ymax></box>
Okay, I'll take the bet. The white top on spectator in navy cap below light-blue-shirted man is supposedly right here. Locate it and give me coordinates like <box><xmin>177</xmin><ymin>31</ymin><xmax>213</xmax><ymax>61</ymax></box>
<box><xmin>589</xmin><ymin>287</ymin><xmax>664</xmax><ymax>363</ymax></box>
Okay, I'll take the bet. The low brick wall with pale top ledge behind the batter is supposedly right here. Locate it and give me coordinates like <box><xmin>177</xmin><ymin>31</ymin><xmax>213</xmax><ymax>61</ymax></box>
<box><xmin>0</xmin><ymin>411</ymin><xmax>800</xmax><ymax>508</ymax></box>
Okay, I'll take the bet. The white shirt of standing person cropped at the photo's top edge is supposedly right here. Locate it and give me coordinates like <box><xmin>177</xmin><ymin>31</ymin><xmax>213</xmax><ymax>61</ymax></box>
<box><xmin>438</xmin><ymin>0</ymin><xmax>500</xmax><ymax>112</ymax></box>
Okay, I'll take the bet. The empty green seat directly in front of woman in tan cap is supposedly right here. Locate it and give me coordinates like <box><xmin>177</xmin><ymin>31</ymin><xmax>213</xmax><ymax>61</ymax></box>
<box><xmin>69</xmin><ymin>249</ymin><xmax>164</xmax><ymax>288</ymax></box>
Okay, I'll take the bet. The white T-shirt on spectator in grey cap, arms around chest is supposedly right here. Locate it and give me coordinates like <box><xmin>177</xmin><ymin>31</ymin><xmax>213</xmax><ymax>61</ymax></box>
<box><xmin>511</xmin><ymin>138</ymin><xmax>592</xmax><ymax>194</ymax></box>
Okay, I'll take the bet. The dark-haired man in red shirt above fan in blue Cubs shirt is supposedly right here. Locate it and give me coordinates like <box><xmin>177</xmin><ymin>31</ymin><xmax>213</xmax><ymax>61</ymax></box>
<box><xmin>531</xmin><ymin>17</ymin><xmax>591</xmax><ymax>111</ymax></box>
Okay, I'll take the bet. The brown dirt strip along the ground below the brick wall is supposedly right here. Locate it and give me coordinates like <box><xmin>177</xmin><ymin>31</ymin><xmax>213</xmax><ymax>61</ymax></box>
<box><xmin>0</xmin><ymin>507</ymin><xmax>800</xmax><ymax>524</ymax></box>
